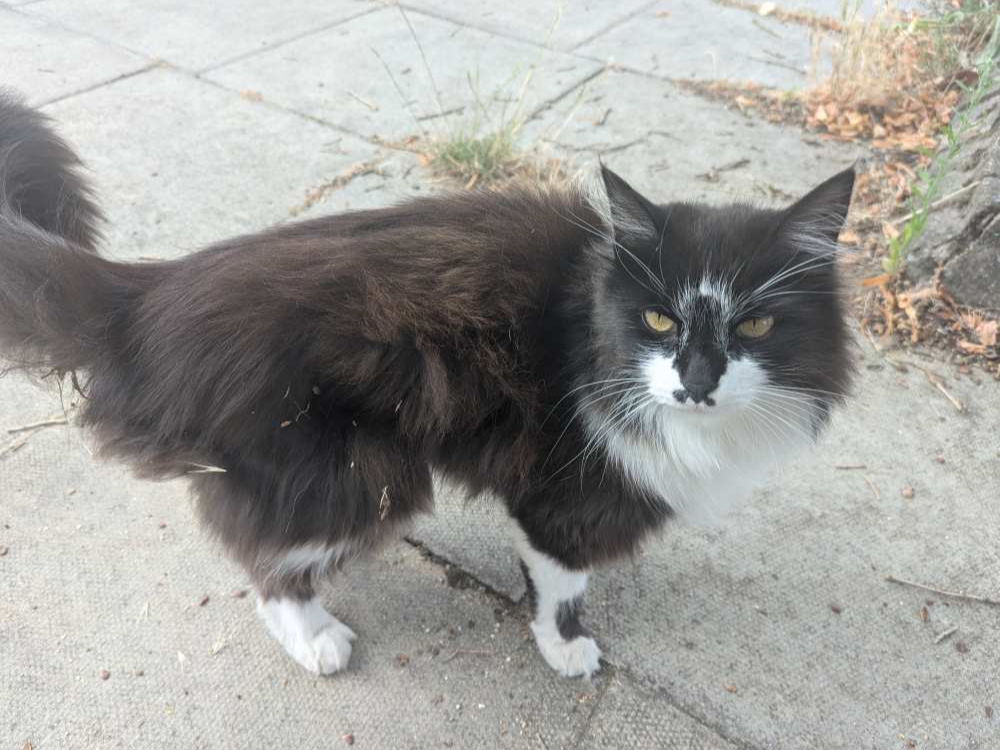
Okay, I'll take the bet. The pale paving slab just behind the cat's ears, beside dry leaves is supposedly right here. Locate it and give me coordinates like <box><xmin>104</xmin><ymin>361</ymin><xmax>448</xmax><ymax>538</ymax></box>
<box><xmin>523</xmin><ymin>71</ymin><xmax>861</xmax><ymax>203</ymax></box>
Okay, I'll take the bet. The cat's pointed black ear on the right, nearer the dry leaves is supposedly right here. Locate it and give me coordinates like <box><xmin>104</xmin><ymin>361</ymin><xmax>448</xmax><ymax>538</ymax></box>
<box><xmin>780</xmin><ymin>166</ymin><xmax>854</xmax><ymax>253</ymax></box>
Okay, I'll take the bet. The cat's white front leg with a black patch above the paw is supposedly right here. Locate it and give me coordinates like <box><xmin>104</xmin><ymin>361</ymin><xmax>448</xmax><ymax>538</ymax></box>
<box><xmin>514</xmin><ymin>526</ymin><xmax>601</xmax><ymax>677</ymax></box>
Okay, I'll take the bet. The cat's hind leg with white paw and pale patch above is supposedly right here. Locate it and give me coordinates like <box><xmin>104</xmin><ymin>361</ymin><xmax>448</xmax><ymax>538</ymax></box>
<box><xmin>253</xmin><ymin>544</ymin><xmax>356</xmax><ymax>675</ymax></box>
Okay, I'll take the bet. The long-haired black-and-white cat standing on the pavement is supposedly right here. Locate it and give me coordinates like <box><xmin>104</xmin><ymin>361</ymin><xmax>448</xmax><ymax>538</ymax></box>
<box><xmin>0</xmin><ymin>96</ymin><xmax>854</xmax><ymax>677</ymax></box>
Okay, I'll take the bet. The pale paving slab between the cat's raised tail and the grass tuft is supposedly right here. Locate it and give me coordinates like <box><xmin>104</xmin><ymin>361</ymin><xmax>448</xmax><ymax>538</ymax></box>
<box><xmin>37</xmin><ymin>68</ymin><xmax>378</xmax><ymax>259</ymax></box>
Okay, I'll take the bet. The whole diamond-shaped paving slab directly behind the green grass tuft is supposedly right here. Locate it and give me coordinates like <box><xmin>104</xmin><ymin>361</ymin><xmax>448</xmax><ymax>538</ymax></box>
<box><xmin>207</xmin><ymin>7</ymin><xmax>601</xmax><ymax>141</ymax></box>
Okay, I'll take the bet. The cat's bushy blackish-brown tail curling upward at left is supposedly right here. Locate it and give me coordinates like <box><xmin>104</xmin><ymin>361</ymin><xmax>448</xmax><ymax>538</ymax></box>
<box><xmin>0</xmin><ymin>91</ymin><xmax>145</xmax><ymax>373</ymax></box>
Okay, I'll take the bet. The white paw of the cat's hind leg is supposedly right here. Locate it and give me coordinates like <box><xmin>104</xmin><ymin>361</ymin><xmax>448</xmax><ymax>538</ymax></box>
<box><xmin>257</xmin><ymin>598</ymin><xmax>357</xmax><ymax>674</ymax></box>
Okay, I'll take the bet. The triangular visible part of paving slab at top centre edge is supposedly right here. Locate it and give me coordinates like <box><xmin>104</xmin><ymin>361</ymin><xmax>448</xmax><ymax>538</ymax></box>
<box><xmin>398</xmin><ymin>0</ymin><xmax>650</xmax><ymax>51</ymax></box>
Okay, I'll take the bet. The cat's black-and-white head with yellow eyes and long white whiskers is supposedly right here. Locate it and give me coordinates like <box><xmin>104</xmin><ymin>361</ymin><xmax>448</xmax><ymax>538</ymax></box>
<box><xmin>593</xmin><ymin>168</ymin><xmax>854</xmax><ymax>452</ymax></box>
